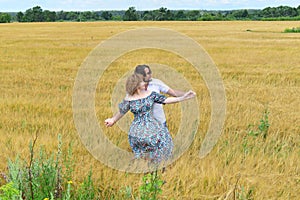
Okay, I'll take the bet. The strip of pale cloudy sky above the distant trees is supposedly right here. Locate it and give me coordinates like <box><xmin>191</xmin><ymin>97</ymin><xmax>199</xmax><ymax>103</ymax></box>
<box><xmin>0</xmin><ymin>0</ymin><xmax>300</xmax><ymax>12</ymax></box>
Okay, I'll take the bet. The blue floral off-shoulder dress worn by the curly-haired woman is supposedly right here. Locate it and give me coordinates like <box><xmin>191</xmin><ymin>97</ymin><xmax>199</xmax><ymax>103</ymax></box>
<box><xmin>119</xmin><ymin>92</ymin><xmax>174</xmax><ymax>163</ymax></box>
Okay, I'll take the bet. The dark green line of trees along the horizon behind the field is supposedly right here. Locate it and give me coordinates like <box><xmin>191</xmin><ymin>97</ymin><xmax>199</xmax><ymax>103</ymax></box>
<box><xmin>0</xmin><ymin>5</ymin><xmax>300</xmax><ymax>23</ymax></box>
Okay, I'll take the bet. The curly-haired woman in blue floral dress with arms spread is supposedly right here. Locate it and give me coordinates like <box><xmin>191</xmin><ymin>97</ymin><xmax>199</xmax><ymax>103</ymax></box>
<box><xmin>105</xmin><ymin>74</ymin><xmax>196</xmax><ymax>164</ymax></box>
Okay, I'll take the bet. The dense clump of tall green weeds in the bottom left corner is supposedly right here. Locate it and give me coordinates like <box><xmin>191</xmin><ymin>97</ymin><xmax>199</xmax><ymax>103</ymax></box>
<box><xmin>0</xmin><ymin>135</ymin><xmax>96</xmax><ymax>200</ymax></box>
